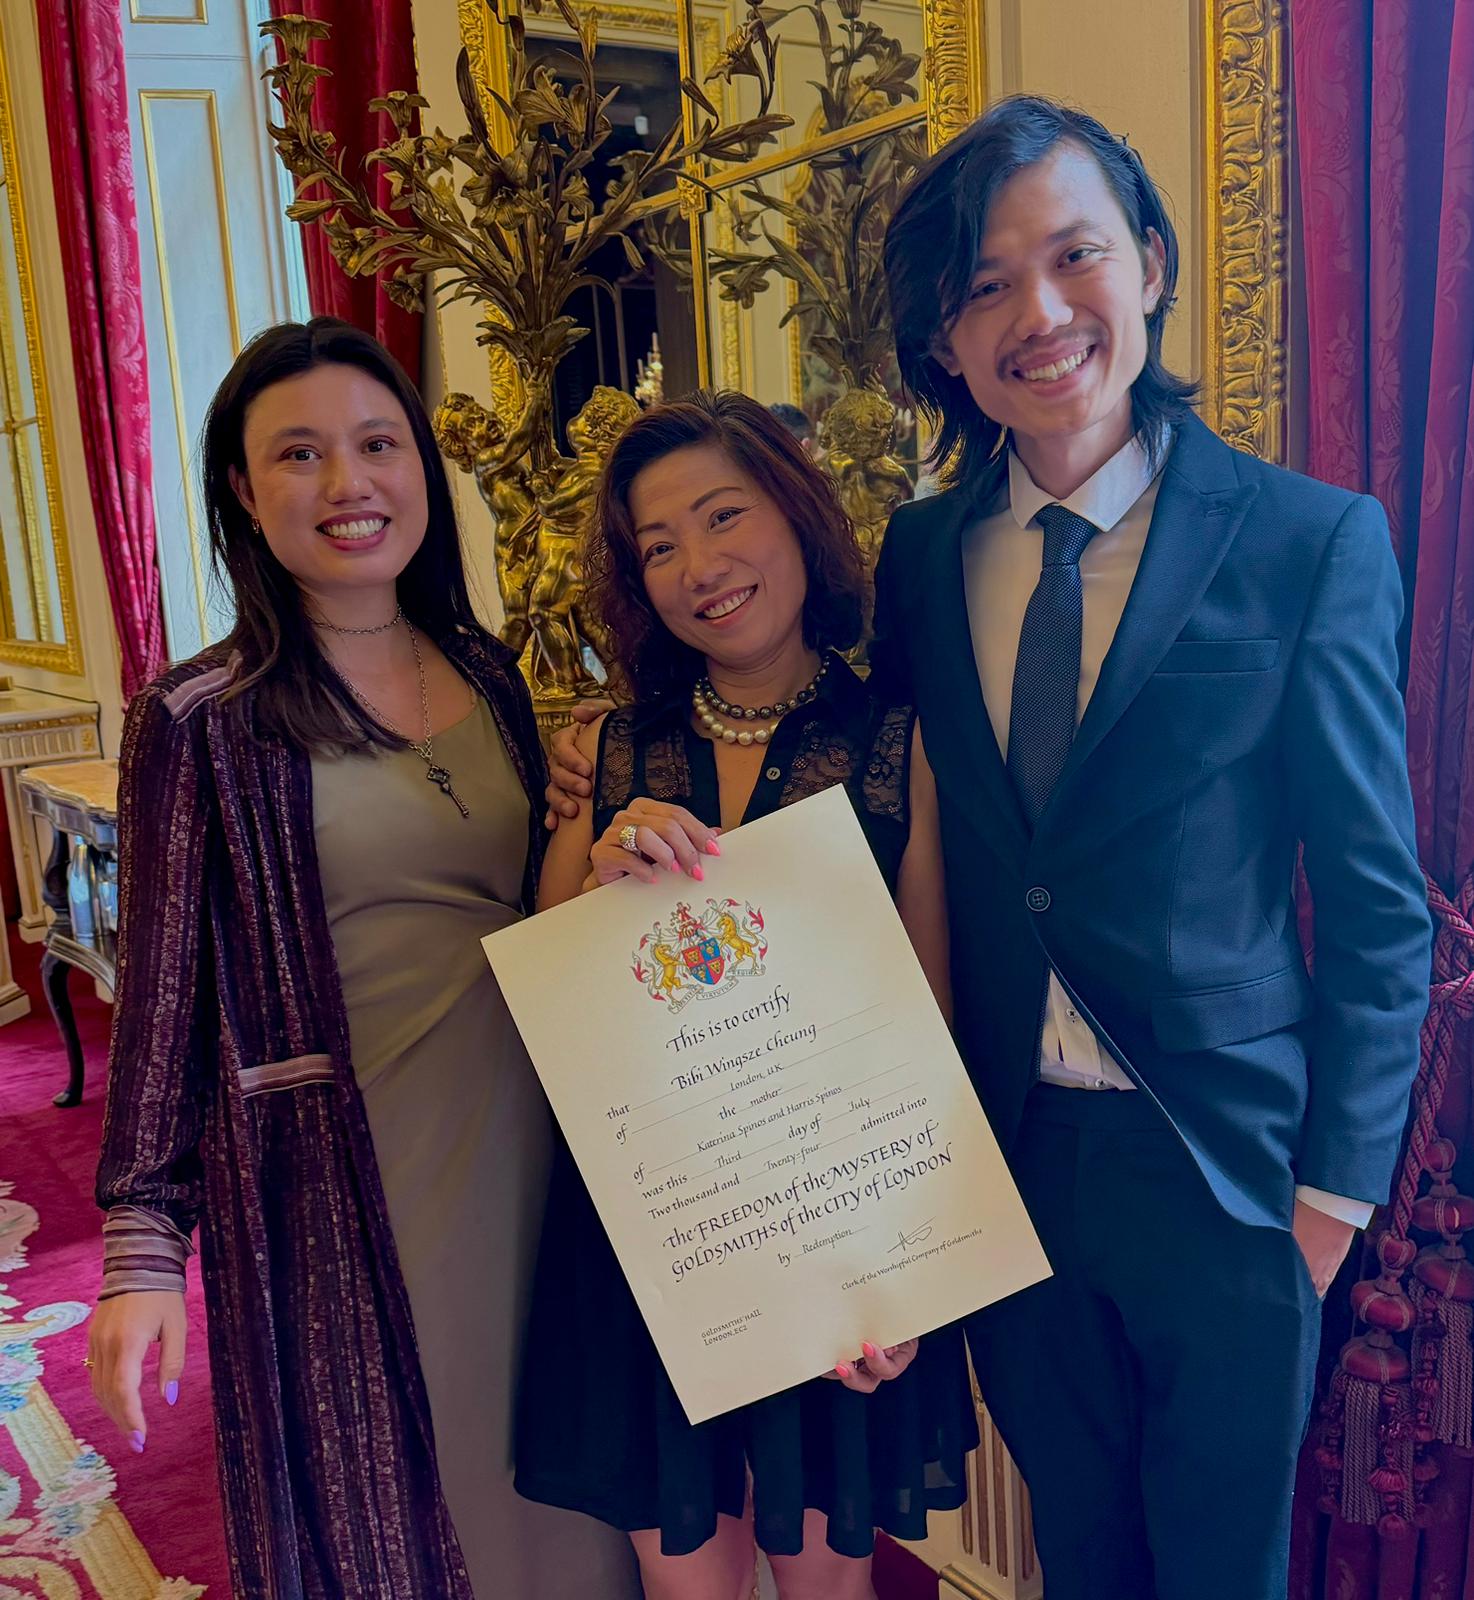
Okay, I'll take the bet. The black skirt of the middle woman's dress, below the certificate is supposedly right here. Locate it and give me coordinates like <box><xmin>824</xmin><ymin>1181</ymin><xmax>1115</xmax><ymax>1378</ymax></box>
<box><xmin>517</xmin><ymin>1141</ymin><xmax>978</xmax><ymax>1557</ymax></box>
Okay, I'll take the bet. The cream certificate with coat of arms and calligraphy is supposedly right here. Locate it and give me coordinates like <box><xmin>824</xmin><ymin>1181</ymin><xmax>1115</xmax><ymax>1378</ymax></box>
<box><xmin>485</xmin><ymin>787</ymin><xmax>1048</xmax><ymax>1422</ymax></box>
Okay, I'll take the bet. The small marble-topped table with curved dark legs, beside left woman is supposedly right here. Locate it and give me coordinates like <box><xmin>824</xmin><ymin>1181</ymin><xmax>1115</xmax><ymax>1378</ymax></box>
<box><xmin>19</xmin><ymin>762</ymin><xmax>118</xmax><ymax>1106</ymax></box>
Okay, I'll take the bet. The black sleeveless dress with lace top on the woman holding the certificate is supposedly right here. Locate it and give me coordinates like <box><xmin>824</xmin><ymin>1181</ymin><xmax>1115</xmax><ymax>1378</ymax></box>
<box><xmin>515</xmin><ymin>659</ymin><xmax>978</xmax><ymax>1557</ymax></box>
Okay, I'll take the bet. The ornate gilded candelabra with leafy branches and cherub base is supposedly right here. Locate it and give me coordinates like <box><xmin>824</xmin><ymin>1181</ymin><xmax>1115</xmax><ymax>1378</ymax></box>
<box><xmin>262</xmin><ymin>0</ymin><xmax>791</xmax><ymax>723</ymax></box>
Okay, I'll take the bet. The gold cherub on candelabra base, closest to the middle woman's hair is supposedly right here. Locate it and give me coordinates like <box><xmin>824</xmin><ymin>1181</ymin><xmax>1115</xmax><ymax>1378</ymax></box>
<box><xmin>528</xmin><ymin>384</ymin><xmax>640</xmax><ymax>702</ymax></box>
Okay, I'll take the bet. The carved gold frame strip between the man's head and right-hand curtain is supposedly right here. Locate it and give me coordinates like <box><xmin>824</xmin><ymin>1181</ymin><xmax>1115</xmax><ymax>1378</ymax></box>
<box><xmin>1202</xmin><ymin>0</ymin><xmax>1290</xmax><ymax>461</ymax></box>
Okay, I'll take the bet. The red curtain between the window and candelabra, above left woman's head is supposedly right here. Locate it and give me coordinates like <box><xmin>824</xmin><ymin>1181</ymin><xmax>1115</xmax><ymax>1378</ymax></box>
<box><xmin>265</xmin><ymin>0</ymin><xmax>419</xmax><ymax>384</ymax></box>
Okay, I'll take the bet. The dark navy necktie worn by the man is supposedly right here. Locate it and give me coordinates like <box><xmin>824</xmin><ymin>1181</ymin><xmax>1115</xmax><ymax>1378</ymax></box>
<box><xmin>1008</xmin><ymin>506</ymin><xmax>1099</xmax><ymax>824</ymax></box>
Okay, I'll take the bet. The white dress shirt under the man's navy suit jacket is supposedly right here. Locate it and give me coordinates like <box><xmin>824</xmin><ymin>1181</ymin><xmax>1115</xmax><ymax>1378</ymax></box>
<box><xmin>963</xmin><ymin>437</ymin><xmax>1372</xmax><ymax>1227</ymax></box>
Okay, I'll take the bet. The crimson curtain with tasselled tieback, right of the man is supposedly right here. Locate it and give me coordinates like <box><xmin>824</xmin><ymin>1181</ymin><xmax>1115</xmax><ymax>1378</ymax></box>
<box><xmin>1290</xmin><ymin>0</ymin><xmax>1474</xmax><ymax>1600</ymax></box>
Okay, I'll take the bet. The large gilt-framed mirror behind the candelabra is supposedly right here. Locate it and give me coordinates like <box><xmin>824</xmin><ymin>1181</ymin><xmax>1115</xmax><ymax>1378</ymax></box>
<box><xmin>461</xmin><ymin>0</ymin><xmax>984</xmax><ymax>438</ymax></box>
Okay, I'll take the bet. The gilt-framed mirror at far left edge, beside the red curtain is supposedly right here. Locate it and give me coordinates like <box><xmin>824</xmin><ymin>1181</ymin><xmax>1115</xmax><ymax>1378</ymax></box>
<box><xmin>0</xmin><ymin>23</ymin><xmax>82</xmax><ymax>674</ymax></box>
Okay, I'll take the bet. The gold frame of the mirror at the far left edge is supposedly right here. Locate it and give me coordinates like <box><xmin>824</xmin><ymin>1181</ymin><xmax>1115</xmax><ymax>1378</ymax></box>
<box><xmin>0</xmin><ymin>34</ymin><xmax>83</xmax><ymax>677</ymax></box>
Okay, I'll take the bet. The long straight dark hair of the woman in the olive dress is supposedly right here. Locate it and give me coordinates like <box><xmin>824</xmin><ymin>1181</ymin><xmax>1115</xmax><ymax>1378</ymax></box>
<box><xmin>200</xmin><ymin>317</ymin><xmax>479</xmax><ymax>750</ymax></box>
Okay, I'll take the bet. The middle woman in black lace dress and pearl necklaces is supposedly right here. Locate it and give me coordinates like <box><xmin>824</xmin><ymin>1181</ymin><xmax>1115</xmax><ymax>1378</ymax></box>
<box><xmin>517</xmin><ymin>394</ymin><xmax>976</xmax><ymax>1600</ymax></box>
